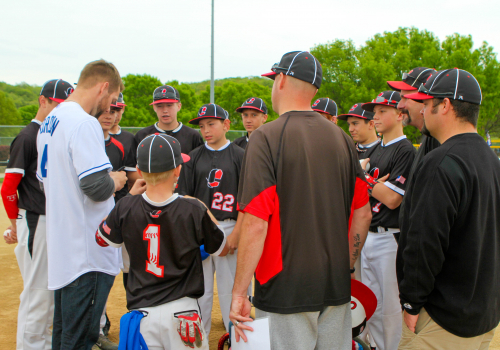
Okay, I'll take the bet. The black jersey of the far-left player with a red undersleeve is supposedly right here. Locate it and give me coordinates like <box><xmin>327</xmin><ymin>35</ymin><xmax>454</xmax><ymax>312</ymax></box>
<box><xmin>5</xmin><ymin>119</ymin><xmax>45</xmax><ymax>215</ymax></box>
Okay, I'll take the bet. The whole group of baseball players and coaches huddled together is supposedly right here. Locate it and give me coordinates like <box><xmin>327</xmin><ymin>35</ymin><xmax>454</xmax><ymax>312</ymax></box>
<box><xmin>1</xmin><ymin>51</ymin><xmax>500</xmax><ymax>350</ymax></box>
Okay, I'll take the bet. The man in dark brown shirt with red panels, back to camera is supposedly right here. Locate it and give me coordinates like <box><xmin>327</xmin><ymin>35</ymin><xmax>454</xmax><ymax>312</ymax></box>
<box><xmin>230</xmin><ymin>51</ymin><xmax>362</xmax><ymax>350</ymax></box>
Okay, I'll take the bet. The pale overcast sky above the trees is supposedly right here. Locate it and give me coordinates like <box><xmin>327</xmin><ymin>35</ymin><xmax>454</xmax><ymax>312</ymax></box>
<box><xmin>0</xmin><ymin>0</ymin><xmax>500</xmax><ymax>85</ymax></box>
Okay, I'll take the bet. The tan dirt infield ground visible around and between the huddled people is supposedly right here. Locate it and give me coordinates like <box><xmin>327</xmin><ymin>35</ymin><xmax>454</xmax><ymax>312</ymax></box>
<box><xmin>0</xmin><ymin>198</ymin><xmax>500</xmax><ymax>350</ymax></box>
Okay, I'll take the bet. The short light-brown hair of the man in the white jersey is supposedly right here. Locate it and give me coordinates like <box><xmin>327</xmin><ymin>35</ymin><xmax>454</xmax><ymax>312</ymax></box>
<box><xmin>78</xmin><ymin>59</ymin><xmax>125</xmax><ymax>92</ymax></box>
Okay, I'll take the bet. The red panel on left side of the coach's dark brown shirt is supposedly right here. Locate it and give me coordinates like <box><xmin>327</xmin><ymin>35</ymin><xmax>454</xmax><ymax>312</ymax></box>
<box><xmin>243</xmin><ymin>186</ymin><xmax>283</xmax><ymax>285</ymax></box>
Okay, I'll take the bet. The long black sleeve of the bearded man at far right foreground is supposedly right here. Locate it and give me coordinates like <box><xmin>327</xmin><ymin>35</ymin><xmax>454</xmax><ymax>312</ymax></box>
<box><xmin>399</xmin><ymin>157</ymin><xmax>468</xmax><ymax>315</ymax></box>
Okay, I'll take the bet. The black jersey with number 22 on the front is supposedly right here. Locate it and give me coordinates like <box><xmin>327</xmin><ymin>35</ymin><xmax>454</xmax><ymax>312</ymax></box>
<box><xmin>177</xmin><ymin>141</ymin><xmax>245</xmax><ymax>221</ymax></box>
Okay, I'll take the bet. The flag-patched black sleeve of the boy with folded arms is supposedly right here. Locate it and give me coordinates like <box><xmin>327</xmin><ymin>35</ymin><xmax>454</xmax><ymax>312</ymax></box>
<box><xmin>380</xmin><ymin>141</ymin><xmax>416</xmax><ymax>196</ymax></box>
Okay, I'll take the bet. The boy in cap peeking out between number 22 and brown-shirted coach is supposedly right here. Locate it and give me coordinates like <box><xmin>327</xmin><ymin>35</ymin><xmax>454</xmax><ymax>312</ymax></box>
<box><xmin>233</xmin><ymin>97</ymin><xmax>267</xmax><ymax>149</ymax></box>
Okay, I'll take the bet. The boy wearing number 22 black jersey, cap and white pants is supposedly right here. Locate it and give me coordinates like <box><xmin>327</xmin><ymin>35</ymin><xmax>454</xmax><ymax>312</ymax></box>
<box><xmin>178</xmin><ymin>104</ymin><xmax>251</xmax><ymax>334</ymax></box>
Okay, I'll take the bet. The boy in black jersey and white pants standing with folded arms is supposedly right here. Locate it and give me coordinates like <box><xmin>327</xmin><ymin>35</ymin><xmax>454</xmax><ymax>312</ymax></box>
<box><xmin>361</xmin><ymin>91</ymin><xmax>415</xmax><ymax>350</ymax></box>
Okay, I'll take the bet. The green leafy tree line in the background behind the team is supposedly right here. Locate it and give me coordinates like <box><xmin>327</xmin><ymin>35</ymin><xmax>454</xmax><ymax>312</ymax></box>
<box><xmin>0</xmin><ymin>28</ymin><xmax>500</xmax><ymax>143</ymax></box>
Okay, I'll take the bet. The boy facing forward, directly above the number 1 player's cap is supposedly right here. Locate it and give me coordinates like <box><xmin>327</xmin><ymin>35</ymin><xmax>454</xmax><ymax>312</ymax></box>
<box><xmin>133</xmin><ymin>85</ymin><xmax>203</xmax><ymax>154</ymax></box>
